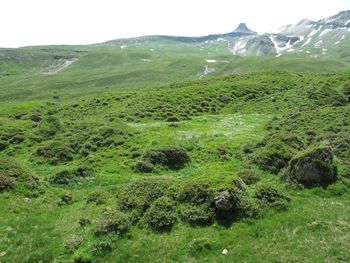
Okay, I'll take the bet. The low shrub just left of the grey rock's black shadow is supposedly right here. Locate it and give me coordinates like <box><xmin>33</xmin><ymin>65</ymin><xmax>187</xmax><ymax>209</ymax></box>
<box><xmin>181</xmin><ymin>204</ymin><xmax>215</xmax><ymax>226</ymax></box>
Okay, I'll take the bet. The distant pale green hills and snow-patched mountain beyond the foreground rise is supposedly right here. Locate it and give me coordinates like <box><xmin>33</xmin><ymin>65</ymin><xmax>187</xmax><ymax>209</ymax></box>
<box><xmin>0</xmin><ymin>11</ymin><xmax>350</xmax><ymax>102</ymax></box>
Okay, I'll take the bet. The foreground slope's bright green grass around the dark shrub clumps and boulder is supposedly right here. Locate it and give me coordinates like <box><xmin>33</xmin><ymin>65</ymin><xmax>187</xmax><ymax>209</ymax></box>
<box><xmin>0</xmin><ymin>71</ymin><xmax>350</xmax><ymax>262</ymax></box>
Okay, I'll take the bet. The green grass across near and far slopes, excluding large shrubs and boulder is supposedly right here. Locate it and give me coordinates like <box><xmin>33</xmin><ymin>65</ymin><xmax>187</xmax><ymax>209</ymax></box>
<box><xmin>0</xmin><ymin>43</ymin><xmax>350</xmax><ymax>262</ymax></box>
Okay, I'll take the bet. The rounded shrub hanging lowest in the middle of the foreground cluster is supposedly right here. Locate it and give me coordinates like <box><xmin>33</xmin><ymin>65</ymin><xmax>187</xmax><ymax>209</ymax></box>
<box><xmin>144</xmin><ymin>196</ymin><xmax>176</xmax><ymax>232</ymax></box>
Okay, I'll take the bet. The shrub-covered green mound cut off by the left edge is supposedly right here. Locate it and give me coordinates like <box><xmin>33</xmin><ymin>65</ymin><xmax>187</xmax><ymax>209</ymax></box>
<box><xmin>0</xmin><ymin>156</ymin><xmax>43</xmax><ymax>197</ymax></box>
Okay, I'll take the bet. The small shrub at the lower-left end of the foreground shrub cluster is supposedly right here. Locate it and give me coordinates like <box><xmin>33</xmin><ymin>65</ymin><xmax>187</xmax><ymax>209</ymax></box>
<box><xmin>94</xmin><ymin>211</ymin><xmax>131</xmax><ymax>236</ymax></box>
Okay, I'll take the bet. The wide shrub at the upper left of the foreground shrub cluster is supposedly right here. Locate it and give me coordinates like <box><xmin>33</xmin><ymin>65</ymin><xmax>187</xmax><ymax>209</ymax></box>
<box><xmin>119</xmin><ymin>177</ymin><xmax>171</xmax><ymax>212</ymax></box>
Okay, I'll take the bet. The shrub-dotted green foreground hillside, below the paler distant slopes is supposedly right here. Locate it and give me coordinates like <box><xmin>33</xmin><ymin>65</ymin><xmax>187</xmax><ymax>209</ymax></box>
<box><xmin>0</xmin><ymin>65</ymin><xmax>350</xmax><ymax>262</ymax></box>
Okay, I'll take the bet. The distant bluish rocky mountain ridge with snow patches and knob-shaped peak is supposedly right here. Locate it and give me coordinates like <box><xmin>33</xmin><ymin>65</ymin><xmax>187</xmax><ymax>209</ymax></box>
<box><xmin>102</xmin><ymin>11</ymin><xmax>350</xmax><ymax>59</ymax></box>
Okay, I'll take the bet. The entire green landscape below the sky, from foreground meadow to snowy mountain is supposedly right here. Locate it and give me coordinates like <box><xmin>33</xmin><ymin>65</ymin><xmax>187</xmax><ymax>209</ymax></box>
<box><xmin>0</xmin><ymin>6</ymin><xmax>350</xmax><ymax>263</ymax></box>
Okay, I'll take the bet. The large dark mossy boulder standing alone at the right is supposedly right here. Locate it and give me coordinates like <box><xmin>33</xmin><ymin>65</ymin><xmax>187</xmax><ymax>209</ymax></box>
<box><xmin>283</xmin><ymin>145</ymin><xmax>337</xmax><ymax>187</ymax></box>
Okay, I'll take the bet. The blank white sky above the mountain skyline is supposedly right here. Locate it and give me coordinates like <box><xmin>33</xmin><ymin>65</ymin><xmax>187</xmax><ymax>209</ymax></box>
<box><xmin>0</xmin><ymin>0</ymin><xmax>350</xmax><ymax>47</ymax></box>
